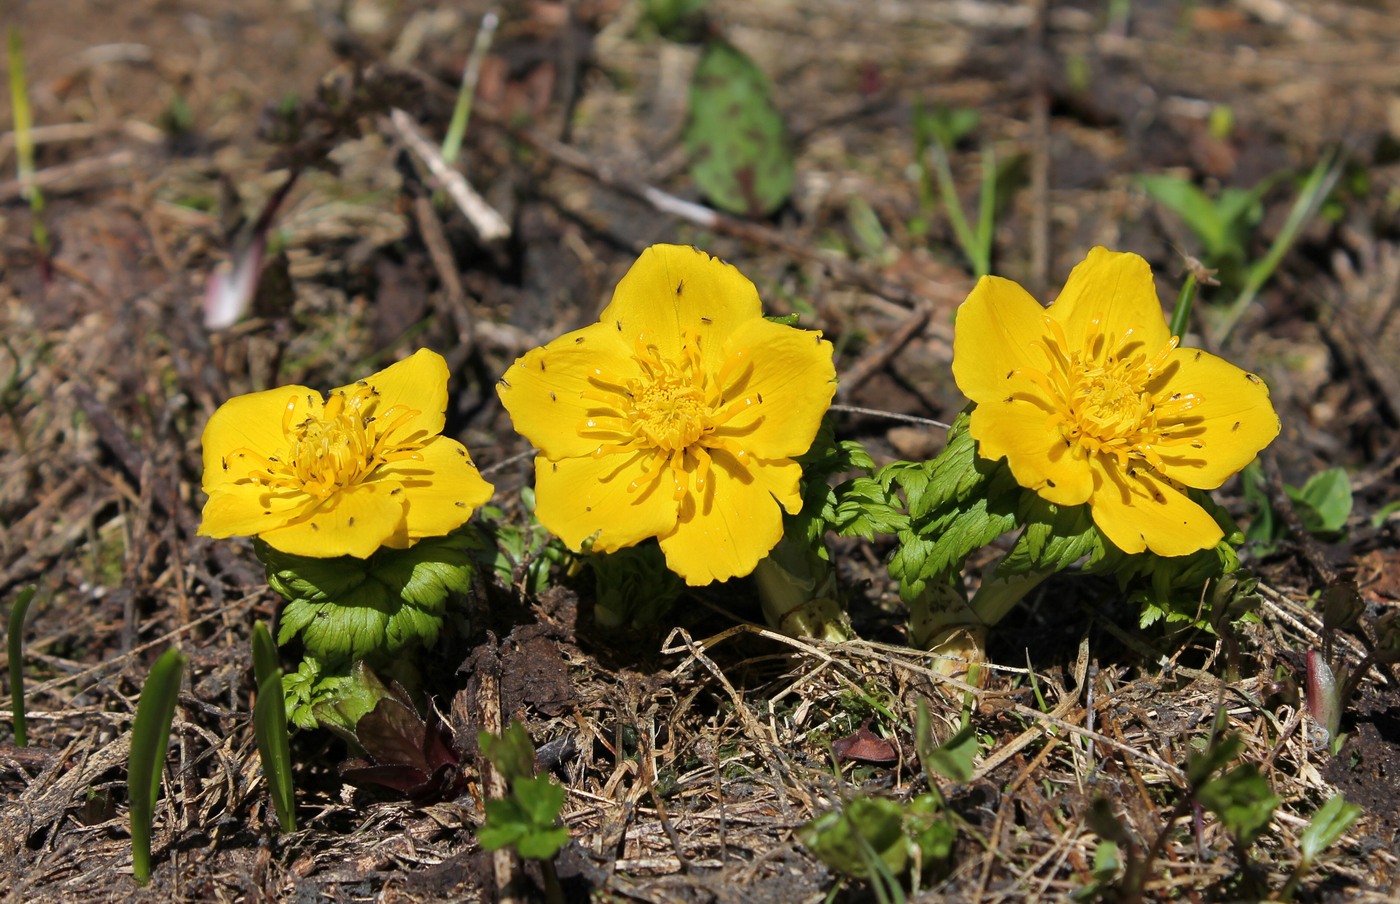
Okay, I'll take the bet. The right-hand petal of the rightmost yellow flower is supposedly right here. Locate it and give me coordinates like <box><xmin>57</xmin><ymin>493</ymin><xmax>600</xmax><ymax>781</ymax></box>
<box><xmin>1156</xmin><ymin>348</ymin><xmax>1278</xmax><ymax>490</ymax></box>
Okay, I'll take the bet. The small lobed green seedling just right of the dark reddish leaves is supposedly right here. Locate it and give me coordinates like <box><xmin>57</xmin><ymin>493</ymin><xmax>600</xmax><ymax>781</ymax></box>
<box><xmin>476</xmin><ymin>722</ymin><xmax>568</xmax><ymax>904</ymax></box>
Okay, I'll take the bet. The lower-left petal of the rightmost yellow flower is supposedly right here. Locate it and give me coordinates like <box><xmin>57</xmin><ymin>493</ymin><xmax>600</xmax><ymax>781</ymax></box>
<box><xmin>967</xmin><ymin>389</ymin><xmax>1093</xmax><ymax>505</ymax></box>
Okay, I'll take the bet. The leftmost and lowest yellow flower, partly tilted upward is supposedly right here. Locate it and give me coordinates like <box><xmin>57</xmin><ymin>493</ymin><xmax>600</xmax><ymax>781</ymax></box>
<box><xmin>199</xmin><ymin>350</ymin><xmax>491</xmax><ymax>558</ymax></box>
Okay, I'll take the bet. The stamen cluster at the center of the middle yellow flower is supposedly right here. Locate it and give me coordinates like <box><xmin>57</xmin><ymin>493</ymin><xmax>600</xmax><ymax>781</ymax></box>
<box><xmin>578</xmin><ymin>333</ymin><xmax>763</xmax><ymax>501</ymax></box>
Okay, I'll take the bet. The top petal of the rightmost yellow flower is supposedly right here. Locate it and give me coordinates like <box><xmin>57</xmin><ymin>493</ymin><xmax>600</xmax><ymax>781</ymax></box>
<box><xmin>1050</xmin><ymin>248</ymin><xmax>1172</xmax><ymax>355</ymax></box>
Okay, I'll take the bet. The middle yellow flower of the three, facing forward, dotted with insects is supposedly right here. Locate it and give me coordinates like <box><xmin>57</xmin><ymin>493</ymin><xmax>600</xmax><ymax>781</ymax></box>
<box><xmin>497</xmin><ymin>245</ymin><xmax>836</xmax><ymax>585</ymax></box>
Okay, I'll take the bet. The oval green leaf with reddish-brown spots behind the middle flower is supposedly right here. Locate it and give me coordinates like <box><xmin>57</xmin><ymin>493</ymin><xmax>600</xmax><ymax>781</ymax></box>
<box><xmin>682</xmin><ymin>39</ymin><xmax>795</xmax><ymax>218</ymax></box>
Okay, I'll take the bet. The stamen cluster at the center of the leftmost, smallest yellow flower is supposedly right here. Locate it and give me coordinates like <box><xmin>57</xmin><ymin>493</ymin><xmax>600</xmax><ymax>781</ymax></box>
<box><xmin>230</xmin><ymin>382</ymin><xmax>426</xmax><ymax>501</ymax></box>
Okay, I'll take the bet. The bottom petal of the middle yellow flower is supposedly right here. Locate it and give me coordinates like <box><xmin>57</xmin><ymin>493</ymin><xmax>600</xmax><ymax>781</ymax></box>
<box><xmin>661</xmin><ymin>451</ymin><xmax>802</xmax><ymax>586</ymax></box>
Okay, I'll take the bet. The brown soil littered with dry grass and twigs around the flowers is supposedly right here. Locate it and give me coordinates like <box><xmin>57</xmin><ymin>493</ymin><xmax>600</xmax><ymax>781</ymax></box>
<box><xmin>0</xmin><ymin>0</ymin><xmax>1400</xmax><ymax>903</ymax></box>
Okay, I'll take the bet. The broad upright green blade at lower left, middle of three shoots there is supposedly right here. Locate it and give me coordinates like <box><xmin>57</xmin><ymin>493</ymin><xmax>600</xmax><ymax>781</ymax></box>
<box><xmin>126</xmin><ymin>647</ymin><xmax>186</xmax><ymax>886</ymax></box>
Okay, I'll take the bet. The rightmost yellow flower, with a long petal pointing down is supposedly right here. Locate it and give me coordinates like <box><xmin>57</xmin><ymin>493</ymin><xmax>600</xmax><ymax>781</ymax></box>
<box><xmin>953</xmin><ymin>248</ymin><xmax>1278</xmax><ymax>556</ymax></box>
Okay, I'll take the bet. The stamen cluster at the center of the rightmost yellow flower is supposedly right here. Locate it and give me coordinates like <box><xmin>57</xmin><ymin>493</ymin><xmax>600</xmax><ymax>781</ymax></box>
<box><xmin>1022</xmin><ymin>316</ymin><xmax>1200</xmax><ymax>467</ymax></box>
